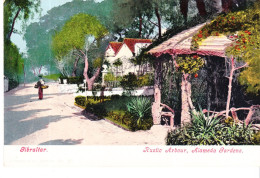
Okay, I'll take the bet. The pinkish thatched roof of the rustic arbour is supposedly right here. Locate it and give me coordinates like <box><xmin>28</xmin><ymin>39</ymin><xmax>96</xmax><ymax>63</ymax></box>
<box><xmin>148</xmin><ymin>23</ymin><xmax>232</xmax><ymax>57</ymax></box>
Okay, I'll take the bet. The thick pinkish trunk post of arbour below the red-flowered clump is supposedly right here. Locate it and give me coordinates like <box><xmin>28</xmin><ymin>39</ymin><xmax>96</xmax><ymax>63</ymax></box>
<box><xmin>181</xmin><ymin>74</ymin><xmax>194</xmax><ymax>124</ymax></box>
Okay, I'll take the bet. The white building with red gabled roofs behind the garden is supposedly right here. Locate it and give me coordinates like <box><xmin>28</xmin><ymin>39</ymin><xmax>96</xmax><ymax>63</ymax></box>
<box><xmin>102</xmin><ymin>38</ymin><xmax>152</xmax><ymax>81</ymax></box>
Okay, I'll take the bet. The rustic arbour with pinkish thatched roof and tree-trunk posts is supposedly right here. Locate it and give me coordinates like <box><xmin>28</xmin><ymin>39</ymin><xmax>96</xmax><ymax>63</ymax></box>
<box><xmin>149</xmin><ymin>24</ymin><xmax>258</xmax><ymax>124</ymax></box>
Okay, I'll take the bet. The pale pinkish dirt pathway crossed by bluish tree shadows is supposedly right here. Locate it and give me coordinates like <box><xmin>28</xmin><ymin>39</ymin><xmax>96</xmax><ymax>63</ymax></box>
<box><xmin>4</xmin><ymin>83</ymin><xmax>171</xmax><ymax>145</ymax></box>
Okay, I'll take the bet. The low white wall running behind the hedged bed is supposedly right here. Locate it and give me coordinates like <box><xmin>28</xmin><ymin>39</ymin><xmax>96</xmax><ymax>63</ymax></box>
<box><xmin>74</xmin><ymin>87</ymin><xmax>154</xmax><ymax>97</ymax></box>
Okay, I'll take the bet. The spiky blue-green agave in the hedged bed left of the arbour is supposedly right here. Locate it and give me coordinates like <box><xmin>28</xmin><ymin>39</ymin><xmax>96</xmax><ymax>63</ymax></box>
<box><xmin>126</xmin><ymin>97</ymin><xmax>151</xmax><ymax>125</ymax></box>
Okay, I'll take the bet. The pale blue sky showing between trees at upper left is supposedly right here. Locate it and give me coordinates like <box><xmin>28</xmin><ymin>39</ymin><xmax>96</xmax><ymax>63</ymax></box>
<box><xmin>11</xmin><ymin>0</ymin><xmax>103</xmax><ymax>53</ymax></box>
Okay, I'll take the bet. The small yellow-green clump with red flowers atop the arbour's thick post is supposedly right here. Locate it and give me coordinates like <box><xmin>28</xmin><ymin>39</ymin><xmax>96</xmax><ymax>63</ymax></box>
<box><xmin>176</xmin><ymin>55</ymin><xmax>204</xmax><ymax>74</ymax></box>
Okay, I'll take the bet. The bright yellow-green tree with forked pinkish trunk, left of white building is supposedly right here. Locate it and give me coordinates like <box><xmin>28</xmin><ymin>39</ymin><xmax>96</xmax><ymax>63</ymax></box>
<box><xmin>52</xmin><ymin>13</ymin><xmax>108</xmax><ymax>90</ymax></box>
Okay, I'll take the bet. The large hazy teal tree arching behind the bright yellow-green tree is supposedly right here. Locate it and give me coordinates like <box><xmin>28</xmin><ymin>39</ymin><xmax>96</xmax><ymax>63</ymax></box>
<box><xmin>24</xmin><ymin>0</ymin><xmax>114</xmax><ymax>78</ymax></box>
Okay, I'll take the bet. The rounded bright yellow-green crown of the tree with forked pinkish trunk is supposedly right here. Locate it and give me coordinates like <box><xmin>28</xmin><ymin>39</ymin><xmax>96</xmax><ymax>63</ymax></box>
<box><xmin>52</xmin><ymin>13</ymin><xmax>108</xmax><ymax>56</ymax></box>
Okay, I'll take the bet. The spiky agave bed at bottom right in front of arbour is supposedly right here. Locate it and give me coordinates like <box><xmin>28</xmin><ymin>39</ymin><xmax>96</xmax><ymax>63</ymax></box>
<box><xmin>166</xmin><ymin>111</ymin><xmax>257</xmax><ymax>145</ymax></box>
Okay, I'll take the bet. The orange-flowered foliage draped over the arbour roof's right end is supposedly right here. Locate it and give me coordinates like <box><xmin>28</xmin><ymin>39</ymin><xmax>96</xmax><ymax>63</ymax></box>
<box><xmin>192</xmin><ymin>1</ymin><xmax>260</xmax><ymax>93</ymax></box>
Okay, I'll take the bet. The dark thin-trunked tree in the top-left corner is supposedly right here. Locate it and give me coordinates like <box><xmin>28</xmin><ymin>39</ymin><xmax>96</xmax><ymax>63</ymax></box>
<box><xmin>4</xmin><ymin>0</ymin><xmax>40</xmax><ymax>39</ymax></box>
